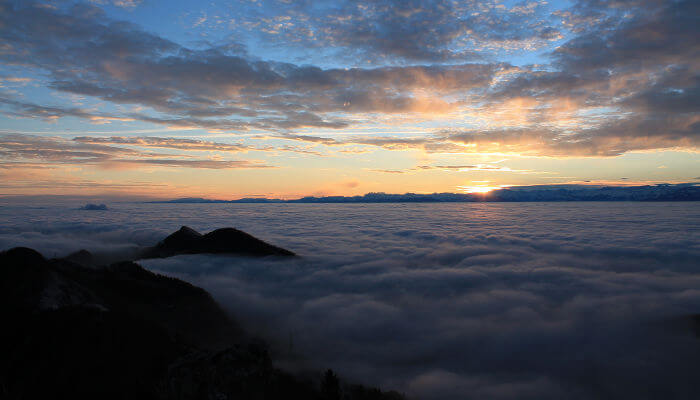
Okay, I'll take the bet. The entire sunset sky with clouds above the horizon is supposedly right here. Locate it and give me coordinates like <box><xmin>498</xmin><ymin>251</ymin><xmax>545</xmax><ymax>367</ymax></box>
<box><xmin>0</xmin><ymin>0</ymin><xmax>700</xmax><ymax>199</ymax></box>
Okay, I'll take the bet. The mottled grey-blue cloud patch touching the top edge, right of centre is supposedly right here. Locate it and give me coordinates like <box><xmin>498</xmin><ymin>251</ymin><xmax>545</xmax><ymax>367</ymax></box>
<box><xmin>239</xmin><ymin>0</ymin><xmax>559</xmax><ymax>64</ymax></box>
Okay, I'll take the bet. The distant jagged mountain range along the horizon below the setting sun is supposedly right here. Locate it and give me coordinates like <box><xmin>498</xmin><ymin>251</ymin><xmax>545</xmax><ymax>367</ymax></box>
<box><xmin>150</xmin><ymin>183</ymin><xmax>700</xmax><ymax>203</ymax></box>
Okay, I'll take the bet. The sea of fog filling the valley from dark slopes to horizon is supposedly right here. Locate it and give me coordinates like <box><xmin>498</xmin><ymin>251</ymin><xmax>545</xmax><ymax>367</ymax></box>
<box><xmin>0</xmin><ymin>202</ymin><xmax>700</xmax><ymax>399</ymax></box>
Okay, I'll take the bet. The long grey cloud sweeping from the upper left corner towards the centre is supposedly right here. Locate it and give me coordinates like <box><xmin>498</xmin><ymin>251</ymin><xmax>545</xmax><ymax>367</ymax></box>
<box><xmin>0</xmin><ymin>0</ymin><xmax>504</xmax><ymax>130</ymax></box>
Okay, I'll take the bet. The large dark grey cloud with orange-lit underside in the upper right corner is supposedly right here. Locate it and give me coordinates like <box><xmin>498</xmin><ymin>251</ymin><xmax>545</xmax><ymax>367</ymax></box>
<box><xmin>474</xmin><ymin>1</ymin><xmax>700</xmax><ymax>156</ymax></box>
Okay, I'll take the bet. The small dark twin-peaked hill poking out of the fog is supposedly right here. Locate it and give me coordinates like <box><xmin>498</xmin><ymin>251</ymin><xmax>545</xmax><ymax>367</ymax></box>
<box><xmin>141</xmin><ymin>226</ymin><xmax>295</xmax><ymax>258</ymax></box>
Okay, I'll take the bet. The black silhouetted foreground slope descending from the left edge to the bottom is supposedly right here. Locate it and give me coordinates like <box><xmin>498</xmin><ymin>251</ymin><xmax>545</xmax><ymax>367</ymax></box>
<box><xmin>0</xmin><ymin>248</ymin><xmax>401</xmax><ymax>399</ymax></box>
